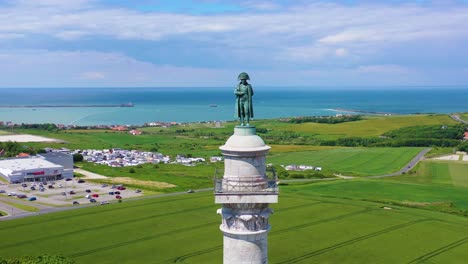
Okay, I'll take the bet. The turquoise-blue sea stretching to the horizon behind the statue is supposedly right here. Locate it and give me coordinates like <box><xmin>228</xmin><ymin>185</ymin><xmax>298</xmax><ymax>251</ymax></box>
<box><xmin>0</xmin><ymin>87</ymin><xmax>468</xmax><ymax>125</ymax></box>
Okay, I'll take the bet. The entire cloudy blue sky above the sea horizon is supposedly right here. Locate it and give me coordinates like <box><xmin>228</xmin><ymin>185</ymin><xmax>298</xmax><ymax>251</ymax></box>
<box><xmin>0</xmin><ymin>0</ymin><xmax>468</xmax><ymax>87</ymax></box>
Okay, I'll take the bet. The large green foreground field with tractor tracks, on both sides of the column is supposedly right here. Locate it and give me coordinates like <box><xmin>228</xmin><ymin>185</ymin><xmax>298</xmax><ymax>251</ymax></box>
<box><xmin>0</xmin><ymin>184</ymin><xmax>468</xmax><ymax>263</ymax></box>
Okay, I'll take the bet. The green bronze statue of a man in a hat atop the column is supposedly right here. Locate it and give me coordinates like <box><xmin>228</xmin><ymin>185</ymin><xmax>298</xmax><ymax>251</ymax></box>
<box><xmin>234</xmin><ymin>72</ymin><xmax>253</xmax><ymax>126</ymax></box>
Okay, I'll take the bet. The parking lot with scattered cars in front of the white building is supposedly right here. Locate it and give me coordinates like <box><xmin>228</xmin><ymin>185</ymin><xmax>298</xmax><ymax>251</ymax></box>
<box><xmin>0</xmin><ymin>178</ymin><xmax>143</xmax><ymax>206</ymax></box>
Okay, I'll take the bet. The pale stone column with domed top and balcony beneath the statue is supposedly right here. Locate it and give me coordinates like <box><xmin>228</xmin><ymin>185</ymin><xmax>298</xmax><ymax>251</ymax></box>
<box><xmin>215</xmin><ymin>126</ymin><xmax>278</xmax><ymax>264</ymax></box>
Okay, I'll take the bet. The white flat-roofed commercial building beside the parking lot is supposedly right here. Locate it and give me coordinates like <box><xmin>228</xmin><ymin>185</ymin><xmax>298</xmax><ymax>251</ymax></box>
<box><xmin>0</xmin><ymin>157</ymin><xmax>66</xmax><ymax>183</ymax></box>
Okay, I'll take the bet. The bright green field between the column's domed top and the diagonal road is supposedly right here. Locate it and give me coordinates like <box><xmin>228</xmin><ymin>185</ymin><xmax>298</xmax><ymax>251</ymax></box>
<box><xmin>267</xmin><ymin>148</ymin><xmax>422</xmax><ymax>176</ymax></box>
